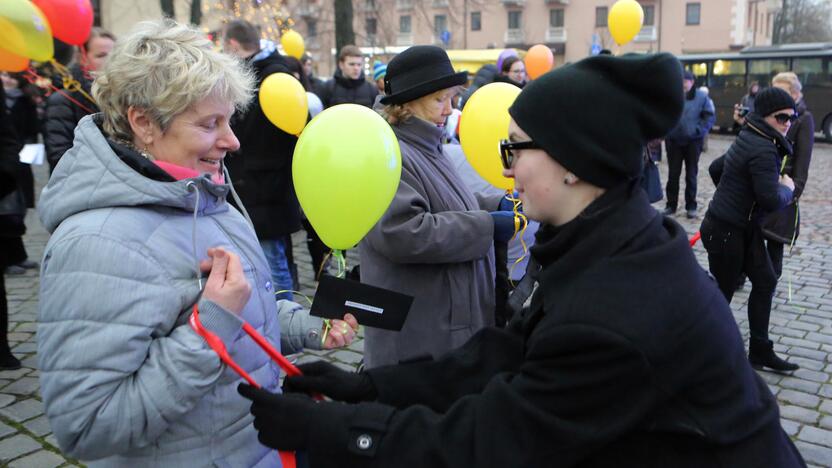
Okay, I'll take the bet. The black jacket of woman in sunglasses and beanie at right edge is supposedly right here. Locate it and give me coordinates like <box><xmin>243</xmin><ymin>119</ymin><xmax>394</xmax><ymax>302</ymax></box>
<box><xmin>706</xmin><ymin>113</ymin><xmax>792</xmax><ymax>228</ymax></box>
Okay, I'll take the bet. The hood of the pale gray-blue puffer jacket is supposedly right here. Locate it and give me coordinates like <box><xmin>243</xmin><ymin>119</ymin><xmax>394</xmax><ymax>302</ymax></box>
<box><xmin>38</xmin><ymin>115</ymin><xmax>229</xmax><ymax>233</ymax></box>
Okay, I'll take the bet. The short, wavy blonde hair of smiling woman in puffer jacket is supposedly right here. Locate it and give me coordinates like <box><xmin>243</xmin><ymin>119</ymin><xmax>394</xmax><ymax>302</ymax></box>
<box><xmin>92</xmin><ymin>19</ymin><xmax>255</xmax><ymax>141</ymax></box>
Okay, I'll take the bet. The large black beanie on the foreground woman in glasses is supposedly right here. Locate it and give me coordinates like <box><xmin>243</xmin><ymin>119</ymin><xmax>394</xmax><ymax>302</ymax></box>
<box><xmin>509</xmin><ymin>53</ymin><xmax>684</xmax><ymax>188</ymax></box>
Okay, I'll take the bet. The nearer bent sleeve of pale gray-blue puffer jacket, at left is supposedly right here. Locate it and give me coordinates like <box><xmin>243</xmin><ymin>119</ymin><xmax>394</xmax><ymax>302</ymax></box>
<box><xmin>38</xmin><ymin>234</ymin><xmax>242</xmax><ymax>460</ymax></box>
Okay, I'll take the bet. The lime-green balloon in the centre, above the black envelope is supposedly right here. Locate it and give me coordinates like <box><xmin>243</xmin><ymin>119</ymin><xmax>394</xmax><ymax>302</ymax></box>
<box><xmin>292</xmin><ymin>104</ymin><xmax>402</xmax><ymax>250</ymax></box>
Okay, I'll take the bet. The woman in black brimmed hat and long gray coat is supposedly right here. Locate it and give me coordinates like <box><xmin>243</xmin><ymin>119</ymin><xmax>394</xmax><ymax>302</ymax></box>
<box><xmin>350</xmin><ymin>46</ymin><xmax>514</xmax><ymax>368</ymax></box>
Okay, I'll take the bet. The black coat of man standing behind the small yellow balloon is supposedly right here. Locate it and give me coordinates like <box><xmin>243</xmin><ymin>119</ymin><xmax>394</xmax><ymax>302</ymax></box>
<box><xmin>225</xmin><ymin>52</ymin><xmax>301</xmax><ymax>240</ymax></box>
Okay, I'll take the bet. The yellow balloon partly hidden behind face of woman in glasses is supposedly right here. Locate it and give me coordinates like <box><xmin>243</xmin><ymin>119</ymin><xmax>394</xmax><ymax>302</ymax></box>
<box><xmin>459</xmin><ymin>83</ymin><xmax>520</xmax><ymax>189</ymax></box>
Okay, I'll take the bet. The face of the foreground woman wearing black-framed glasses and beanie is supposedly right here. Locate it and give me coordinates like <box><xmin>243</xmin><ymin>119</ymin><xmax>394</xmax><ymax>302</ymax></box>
<box><xmin>503</xmin><ymin>119</ymin><xmax>569</xmax><ymax>226</ymax></box>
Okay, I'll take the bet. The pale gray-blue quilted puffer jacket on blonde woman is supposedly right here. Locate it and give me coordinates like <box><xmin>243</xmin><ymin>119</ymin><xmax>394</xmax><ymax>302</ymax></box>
<box><xmin>38</xmin><ymin>116</ymin><xmax>320</xmax><ymax>467</ymax></box>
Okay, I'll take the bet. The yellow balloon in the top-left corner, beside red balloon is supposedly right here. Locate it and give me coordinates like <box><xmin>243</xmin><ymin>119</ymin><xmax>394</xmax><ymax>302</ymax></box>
<box><xmin>0</xmin><ymin>0</ymin><xmax>55</xmax><ymax>62</ymax></box>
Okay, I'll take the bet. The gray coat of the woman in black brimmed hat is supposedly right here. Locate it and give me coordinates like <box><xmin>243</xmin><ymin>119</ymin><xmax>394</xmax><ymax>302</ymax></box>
<box><xmin>359</xmin><ymin>117</ymin><xmax>499</xmax><ymax>368</ymax></box>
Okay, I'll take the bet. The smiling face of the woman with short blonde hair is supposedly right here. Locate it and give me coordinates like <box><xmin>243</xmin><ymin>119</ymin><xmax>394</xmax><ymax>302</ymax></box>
<box><xmin>141</xmin><ymin>97</ymin><xmax>240</xmax><ymax>179</ymax></box>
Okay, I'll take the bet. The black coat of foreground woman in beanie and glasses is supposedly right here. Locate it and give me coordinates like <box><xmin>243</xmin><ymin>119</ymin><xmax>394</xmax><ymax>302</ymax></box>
<box><xmin>309</xmin><ymin>186</ymin><xmax>805</xmax><ymax>468</ymax></box>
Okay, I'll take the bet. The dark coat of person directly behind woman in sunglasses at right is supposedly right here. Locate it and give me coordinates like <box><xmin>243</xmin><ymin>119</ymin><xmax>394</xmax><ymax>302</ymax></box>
<box><xmin>763</xmin><ymin>99</ymin><xmax>815</xmax><ymax>244</ymax></box>
